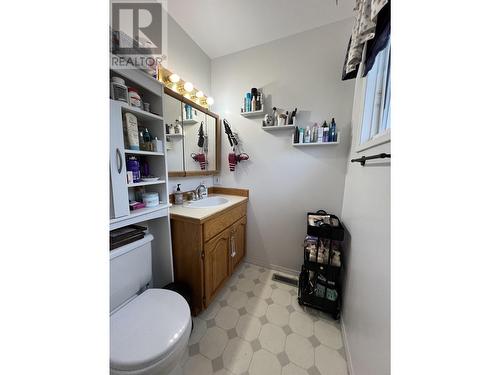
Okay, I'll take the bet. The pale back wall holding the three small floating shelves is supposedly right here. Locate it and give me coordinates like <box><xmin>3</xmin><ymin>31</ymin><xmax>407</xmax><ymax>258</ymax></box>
<box><xmin>212</xmin><ymin>20</ymin><xmax>354</xmax><ymax>270</ymax></box>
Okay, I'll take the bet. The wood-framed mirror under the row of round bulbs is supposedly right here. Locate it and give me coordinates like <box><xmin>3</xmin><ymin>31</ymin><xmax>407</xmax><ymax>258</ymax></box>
<box><xmin>164</xmin><ymin>88</ymin><xmax>220</xmax><ymax>177</ymax></box>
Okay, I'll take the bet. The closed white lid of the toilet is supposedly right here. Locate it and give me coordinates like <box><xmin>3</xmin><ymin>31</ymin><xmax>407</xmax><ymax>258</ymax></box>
<box><xmin>110</xmin><ymin>289</ymin><xmax>191</xmax><ymax>370</ymax></box>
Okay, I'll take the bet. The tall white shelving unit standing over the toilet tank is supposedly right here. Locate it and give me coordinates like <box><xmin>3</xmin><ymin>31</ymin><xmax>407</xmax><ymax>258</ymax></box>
<box><xmin>108</xmin><ymin>58</ymin><xmax>174</xmax><ymax>288</ymax></box>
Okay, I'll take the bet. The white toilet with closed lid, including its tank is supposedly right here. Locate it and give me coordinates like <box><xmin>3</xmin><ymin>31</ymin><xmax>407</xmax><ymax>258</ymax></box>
<box><xmin>110</xmin><ymin>234</ymin><xmax>191</xmax><ymax>375</ymax></box>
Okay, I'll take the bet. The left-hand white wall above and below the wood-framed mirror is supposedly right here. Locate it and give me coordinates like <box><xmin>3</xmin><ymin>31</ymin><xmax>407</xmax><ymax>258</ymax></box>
<box><xmin>167</xmin><ymin>16</ymin><xmax>213</xmax><ymax>193</ymax></box>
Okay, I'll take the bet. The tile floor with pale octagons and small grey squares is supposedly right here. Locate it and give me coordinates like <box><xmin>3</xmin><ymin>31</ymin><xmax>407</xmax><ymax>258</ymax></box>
<box><xmin>170</xmin><ymin>263</ymin><xmax>347</xmax><ymax>375</ymax></box>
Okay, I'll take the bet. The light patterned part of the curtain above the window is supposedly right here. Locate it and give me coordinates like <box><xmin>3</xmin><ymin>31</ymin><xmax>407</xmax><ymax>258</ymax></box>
<box><xmin>342</xmin><ymin>0</ymin><xmax>390</xmax><ymax>80</ymax></box>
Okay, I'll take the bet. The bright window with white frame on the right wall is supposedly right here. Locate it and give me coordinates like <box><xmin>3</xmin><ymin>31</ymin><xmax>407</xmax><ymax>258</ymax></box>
<box><xmin>358</xmin><ymin>42</ymin><xmax>391</xmax><ymax>151</ymax></box>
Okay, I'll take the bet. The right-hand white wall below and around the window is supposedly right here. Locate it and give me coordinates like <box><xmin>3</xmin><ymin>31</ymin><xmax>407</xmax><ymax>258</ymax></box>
<box><xmin>342</xmin><ymin>70</ymin><xmax>391</xmax><ymax>375</ymax></box>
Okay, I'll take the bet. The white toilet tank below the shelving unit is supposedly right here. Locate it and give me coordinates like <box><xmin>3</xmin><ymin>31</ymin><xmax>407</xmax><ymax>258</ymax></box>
<box><xmin>109</xmin><ymin>234</ymin><xmax>153</xmax><ymax>312</ymax></box>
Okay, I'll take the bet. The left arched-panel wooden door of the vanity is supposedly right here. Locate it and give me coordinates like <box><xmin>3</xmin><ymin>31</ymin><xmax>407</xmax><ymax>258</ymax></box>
<box><xmin>204</xmin><ymin>228</ymin><xmax>231</xmax><ymax>308</ymax></box>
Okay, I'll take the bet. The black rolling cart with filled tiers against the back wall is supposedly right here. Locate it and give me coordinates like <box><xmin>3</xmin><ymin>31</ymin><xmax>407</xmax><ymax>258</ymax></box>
<box><xmin>298</xmin><ymin>210</ymin><xmax>344</xmax><ymax>319</ymax></box>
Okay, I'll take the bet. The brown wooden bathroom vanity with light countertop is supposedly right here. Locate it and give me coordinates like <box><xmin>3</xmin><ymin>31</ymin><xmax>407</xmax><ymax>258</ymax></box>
<box><xmin>170</xmin><ymin>187</ymin><xmax>248</xmax><ymax>315</ymax></box>
